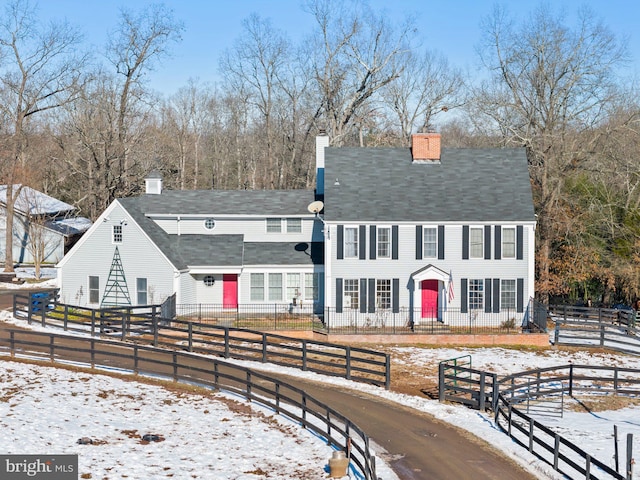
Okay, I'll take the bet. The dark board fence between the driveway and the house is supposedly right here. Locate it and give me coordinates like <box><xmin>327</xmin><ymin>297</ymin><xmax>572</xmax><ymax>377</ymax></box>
<box><xmin>13</xmin><ymin>293</ymin><xmax>391</xmax><ymax>389</ymax></box>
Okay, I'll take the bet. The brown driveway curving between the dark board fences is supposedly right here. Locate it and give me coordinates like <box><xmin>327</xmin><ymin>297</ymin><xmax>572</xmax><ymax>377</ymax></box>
<box><xmin>0</xmin><ymin>291</ymin><xmax>536</xmax><ymax>480</ymax></box>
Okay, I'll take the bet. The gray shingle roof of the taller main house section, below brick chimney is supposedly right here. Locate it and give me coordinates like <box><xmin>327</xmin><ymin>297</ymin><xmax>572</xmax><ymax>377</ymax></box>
<box><xmin>324</xmin><ymin>148</ymin><xmax>535</xmax><ymax>223</ymax></box>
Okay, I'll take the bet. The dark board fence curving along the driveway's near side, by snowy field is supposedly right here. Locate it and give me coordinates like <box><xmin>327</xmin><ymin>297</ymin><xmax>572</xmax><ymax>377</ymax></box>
<box><xmin>0</xmin><ymin>330</ymin><xmax>377</xmax><ymax>480</ymax></box>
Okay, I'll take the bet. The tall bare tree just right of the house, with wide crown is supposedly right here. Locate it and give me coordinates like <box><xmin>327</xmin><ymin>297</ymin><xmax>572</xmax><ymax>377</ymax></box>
<box><xmin>472</xmin><ymin>6</ymin><xmax>626</xmax><ymax>300</ymax></box>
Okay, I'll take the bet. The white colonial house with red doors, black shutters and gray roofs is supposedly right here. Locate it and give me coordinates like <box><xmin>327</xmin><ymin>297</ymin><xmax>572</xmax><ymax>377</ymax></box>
<box><xmin>58</xmin><ymin>134</ymin><xmax>536</xmax><ymax>324</ymax></box>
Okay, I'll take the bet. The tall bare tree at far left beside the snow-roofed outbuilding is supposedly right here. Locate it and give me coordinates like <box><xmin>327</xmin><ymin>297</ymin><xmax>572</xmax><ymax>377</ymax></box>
<box><xmin>0</xmin><ymin>0</ymin><xmax>86</xmax><ymax>272</ymax></box>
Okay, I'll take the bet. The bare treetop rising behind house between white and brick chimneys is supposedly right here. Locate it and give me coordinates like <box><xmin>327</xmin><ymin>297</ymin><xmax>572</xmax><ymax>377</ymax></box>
<box><xmin>306</xmin><ymin>0</ymin><xmax>413</xmax><ymax>146</ymax></box>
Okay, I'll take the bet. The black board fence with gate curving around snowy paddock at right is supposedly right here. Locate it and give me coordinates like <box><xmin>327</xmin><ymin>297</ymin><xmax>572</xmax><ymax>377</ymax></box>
<box><xmin>438</xmin><ymin>357</ymin><xmax>640</xmax><ymax>480</ymax></box>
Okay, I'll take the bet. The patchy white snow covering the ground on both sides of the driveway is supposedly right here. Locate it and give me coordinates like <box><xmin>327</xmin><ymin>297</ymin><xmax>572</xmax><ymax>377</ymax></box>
<box><xmin>0</xmin><ymin>276</ymin><xmax>640</xmax><ymax>480</ymax></box>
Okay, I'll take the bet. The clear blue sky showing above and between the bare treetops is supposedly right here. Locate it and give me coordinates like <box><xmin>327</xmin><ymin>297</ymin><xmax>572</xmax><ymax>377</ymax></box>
<box><xmin>33</xmin><ymin>0</ymin><xmax>640</xmax><ymax>94</ymax></box>
